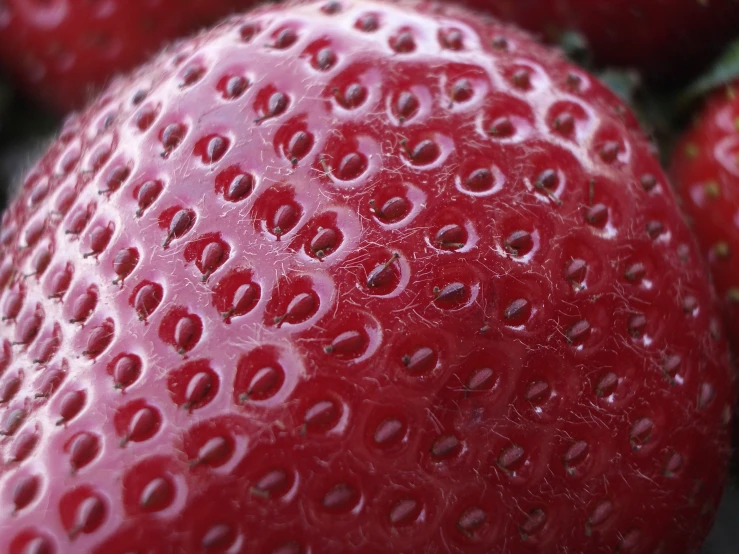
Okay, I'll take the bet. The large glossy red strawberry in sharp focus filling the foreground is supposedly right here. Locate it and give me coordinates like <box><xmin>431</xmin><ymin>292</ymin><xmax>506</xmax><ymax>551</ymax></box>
<box><xmin>0</xmin><ymin>1</ymin><xmax>732</xmax><ymax>554</ymax></box>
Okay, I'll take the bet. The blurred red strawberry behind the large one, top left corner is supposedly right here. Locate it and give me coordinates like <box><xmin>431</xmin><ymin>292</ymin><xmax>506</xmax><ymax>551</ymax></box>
<box><xmin>0</xmin><ymin>0</ymin><xmax>255</xmax><ymax>111</ymax></box>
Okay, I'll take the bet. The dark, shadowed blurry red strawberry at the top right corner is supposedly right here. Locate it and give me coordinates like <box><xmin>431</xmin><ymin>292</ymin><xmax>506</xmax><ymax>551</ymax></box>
<box><xmin>464</xmin><ymin>0</ymin><xmax>739</xmax><ymax>80</ymax></box>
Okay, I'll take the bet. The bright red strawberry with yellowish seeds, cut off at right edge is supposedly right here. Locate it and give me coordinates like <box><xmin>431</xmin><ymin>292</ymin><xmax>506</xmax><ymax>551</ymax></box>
<box><xmin>671</xmin><ymin>86</ymin><xmax>739</xmax><ymax>352</ymax></box>
